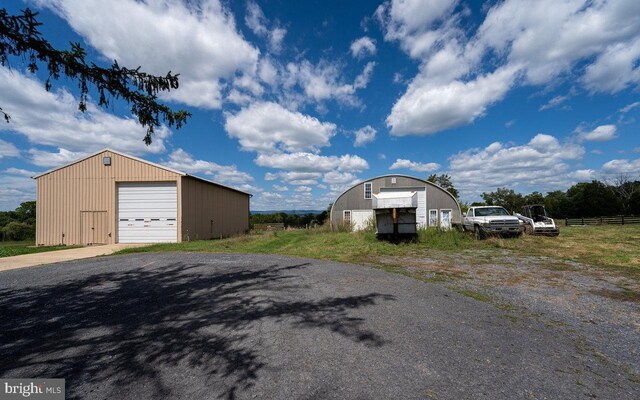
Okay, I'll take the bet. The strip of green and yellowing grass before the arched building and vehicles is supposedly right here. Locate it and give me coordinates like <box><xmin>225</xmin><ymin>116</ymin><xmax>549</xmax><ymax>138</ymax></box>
<box><xmin>120</xmin><ymin>225</ymin><xmax>640</xmax><ymax>276</ymax></box>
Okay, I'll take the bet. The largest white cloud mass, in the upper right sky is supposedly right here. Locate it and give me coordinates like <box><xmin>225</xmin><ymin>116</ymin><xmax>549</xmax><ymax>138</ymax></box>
<box><xmin>376</xmin><ymin>0</ymin><xmax>640</xmax><ymax>136</ymax></box>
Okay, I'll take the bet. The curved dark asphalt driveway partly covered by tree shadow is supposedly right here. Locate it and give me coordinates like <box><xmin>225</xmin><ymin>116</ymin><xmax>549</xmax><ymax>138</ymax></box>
<box><xmin>0</xmin><ymin>253</ymin><xmax>640</xmax><ymax>399</ymax></box>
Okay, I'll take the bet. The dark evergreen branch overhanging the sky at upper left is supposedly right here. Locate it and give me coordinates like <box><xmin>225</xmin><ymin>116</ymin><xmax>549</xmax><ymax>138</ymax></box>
<box><xmin>0</xmin><ymin>8</ymin><xmax>191</xmax><ymax>145</ymax></box>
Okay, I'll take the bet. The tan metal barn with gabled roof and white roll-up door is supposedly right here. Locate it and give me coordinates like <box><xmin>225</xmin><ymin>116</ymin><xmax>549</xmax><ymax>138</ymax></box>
<box><xmin>34</xmin><ymin>149</ymin><xmax>251</xmax><ymax>245</ymax></box>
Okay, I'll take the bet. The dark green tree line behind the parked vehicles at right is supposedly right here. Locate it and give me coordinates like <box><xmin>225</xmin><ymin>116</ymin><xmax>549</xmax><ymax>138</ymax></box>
<box><xmin>471</xmin><ymin>176</ymin><xmax>640</xmax><ymax>218</ymax></box>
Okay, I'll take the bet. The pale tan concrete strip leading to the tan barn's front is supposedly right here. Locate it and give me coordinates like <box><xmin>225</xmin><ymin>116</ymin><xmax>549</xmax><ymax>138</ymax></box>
<box><xmin>0</xmin><ymin>243</ymin><xmax>148</xmax><ymax>271</ymax></box>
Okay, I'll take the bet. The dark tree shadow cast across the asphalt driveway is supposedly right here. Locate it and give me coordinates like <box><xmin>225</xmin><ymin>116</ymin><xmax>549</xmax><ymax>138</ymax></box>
<box><xmin>0</xmin><ymin>263</ymin><xmax>394</xmax><ymax>399</ymax></box>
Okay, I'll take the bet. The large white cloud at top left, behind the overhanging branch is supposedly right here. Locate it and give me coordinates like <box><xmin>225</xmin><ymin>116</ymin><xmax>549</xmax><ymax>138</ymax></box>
<box><xmin>37</xmin><ymin>0</ymin><xmax>260</xmax><ymax>108</ymax></box>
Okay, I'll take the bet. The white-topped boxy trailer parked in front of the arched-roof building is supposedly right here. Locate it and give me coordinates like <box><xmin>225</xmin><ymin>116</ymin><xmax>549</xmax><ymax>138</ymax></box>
<box><xmin>373</xmin><ymin>191</ymin><xmax>418</xmax><ymax>236</ymax></box>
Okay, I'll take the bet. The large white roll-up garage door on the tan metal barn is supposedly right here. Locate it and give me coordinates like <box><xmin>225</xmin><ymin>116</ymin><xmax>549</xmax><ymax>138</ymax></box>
<box><xmin>118</xmin><ymin>182</ymin><xmax>178</xmax><ymax>243</ymax></box>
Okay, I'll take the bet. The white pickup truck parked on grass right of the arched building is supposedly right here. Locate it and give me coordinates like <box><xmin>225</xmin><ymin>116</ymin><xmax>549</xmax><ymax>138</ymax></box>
<box><xmin>462</xmin><ymin>206</ymin><xmax>524</xmax><ymax>239</ymax></box>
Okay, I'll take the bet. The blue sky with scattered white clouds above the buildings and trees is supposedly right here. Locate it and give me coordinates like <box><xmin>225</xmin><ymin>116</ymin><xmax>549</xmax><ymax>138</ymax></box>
<box><xmin>0</xmin><ymin>0</ymin><xmax>640</xmax><ymax>210</ymax></box>
